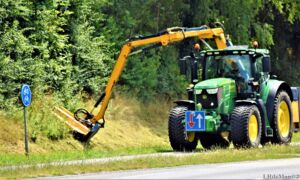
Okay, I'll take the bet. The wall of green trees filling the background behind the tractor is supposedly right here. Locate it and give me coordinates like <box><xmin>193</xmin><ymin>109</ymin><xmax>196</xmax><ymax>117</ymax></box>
<box><xmin>0</xmin><ymin>0</ymin><xmax>300</xmax><ymax>139</ymax></box>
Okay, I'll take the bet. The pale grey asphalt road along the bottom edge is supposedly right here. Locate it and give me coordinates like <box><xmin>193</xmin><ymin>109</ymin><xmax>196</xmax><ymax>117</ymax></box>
<box><xmin>40</xmin><ymin>158</ymin><xmax>300</xmax><ymax>180</ymax></box>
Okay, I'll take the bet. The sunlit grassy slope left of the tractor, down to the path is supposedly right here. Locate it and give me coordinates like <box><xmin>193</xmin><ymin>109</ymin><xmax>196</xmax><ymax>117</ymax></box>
<box><xmin>0</xmin><ymin>96</ymin><xmax>172</xmax><ymax>165</ymax></box>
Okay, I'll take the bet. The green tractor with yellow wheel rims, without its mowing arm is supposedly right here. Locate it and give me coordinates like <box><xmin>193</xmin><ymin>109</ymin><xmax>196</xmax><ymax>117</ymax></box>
<box><xmin>168</xmin><ymin>46</ymin><xmax>300</xmax><ymax>151</ymax></box>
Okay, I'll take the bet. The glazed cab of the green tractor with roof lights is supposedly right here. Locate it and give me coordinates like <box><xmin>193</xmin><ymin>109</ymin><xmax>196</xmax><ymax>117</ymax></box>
<box><xmin>201</xmin><ymin>47</ymin><xmax>270</xmax><ymax>95</ymax></box>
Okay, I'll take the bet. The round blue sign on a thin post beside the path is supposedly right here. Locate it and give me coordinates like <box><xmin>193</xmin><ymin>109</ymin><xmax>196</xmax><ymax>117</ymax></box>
<box><xmin>21</xmin><ymin>84</ymin><xmax>31</xmax><ymax>156</ymax></box>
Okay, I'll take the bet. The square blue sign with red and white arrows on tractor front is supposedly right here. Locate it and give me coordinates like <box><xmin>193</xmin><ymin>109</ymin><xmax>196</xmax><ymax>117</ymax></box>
<box><xmin>185</xmin><ymin>111</ymin><xmax>205</xmax><ymax>131</ymax></box>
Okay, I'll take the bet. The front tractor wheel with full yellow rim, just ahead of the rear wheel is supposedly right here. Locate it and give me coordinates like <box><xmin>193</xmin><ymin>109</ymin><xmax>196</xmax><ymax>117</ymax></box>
<box><xmin>230</xmin><ymin>105</ymin><xmax>262</xmax><ymax>148</ymax></box>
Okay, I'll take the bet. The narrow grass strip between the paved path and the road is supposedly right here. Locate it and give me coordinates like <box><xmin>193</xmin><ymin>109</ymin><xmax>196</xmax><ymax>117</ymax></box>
<box><xmin>0</xmin><ymin>145</ymin><xmax>300</xmax><ymax>178</ymax></box>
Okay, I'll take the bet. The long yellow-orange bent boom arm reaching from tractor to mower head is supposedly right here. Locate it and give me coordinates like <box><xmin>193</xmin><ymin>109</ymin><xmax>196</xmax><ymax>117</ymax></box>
<box><xmin>91</xmin><ymin>28</ymin><xmax>226</xmax><ymax>123</ymax></box>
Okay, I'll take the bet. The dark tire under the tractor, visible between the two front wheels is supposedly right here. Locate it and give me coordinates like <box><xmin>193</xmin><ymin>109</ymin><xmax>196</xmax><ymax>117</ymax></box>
<box><xmin>199</xmin><ymin>132</ymin><xmax>230</xmax><ymax>149</ymax></box>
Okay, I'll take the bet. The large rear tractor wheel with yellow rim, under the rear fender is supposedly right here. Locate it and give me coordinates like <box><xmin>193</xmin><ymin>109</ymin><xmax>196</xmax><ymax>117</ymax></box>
<box><xmin>271</xmin><ymin>91</ymin><xmax>293</xmax><ymax>144</ymax></box>
